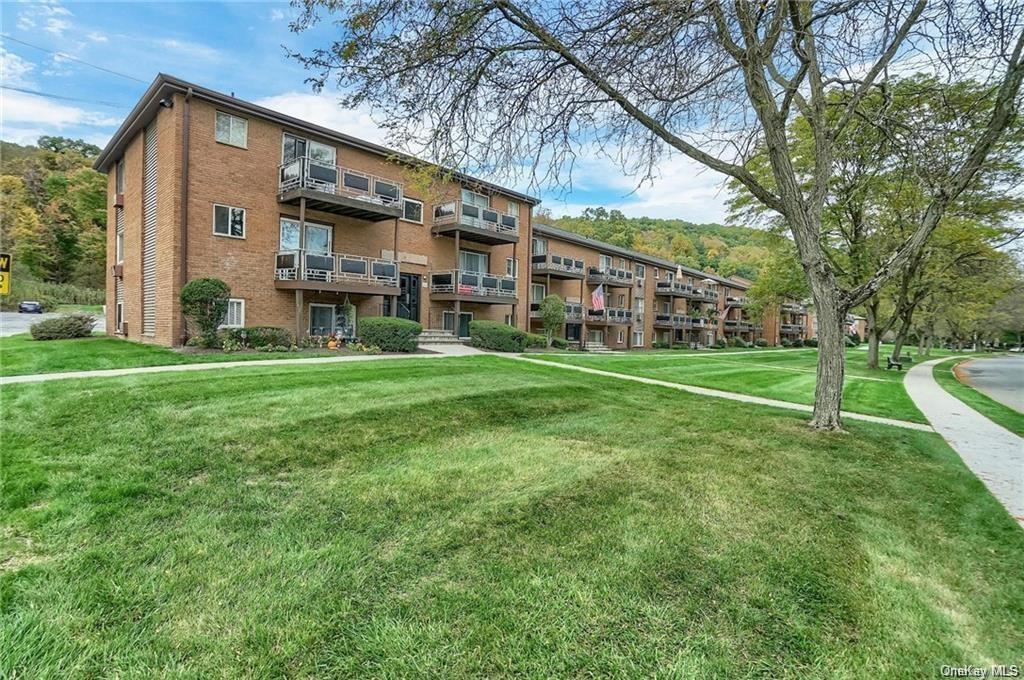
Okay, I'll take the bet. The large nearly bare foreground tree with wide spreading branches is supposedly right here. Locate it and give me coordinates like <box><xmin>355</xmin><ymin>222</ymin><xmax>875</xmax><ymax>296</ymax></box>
<box><xmin>293</xmin><ymin>0</ymin><xmax>1024</xmax><ymax>429</ymax></box>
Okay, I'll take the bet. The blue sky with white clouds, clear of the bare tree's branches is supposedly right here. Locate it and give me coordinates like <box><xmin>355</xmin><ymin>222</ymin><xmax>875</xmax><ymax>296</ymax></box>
<box><xmin>0</xmin><ymin>1</ymin><xmax>737</xmax><ymax>222</ymax></box>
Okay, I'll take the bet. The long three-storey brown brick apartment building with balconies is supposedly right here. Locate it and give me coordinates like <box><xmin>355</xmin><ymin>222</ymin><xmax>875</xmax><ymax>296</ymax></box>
<box><xmin>95</xmin><ymin>75</ymin><xmax>808</xmax><ymax>348</ymax></box>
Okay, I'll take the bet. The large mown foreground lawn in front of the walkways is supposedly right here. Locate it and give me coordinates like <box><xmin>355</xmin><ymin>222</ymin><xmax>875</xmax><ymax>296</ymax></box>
<box><xmin>0</xmin><ymin>356</ymin><xmax>1024</xmax><ymax>678</ymax></box>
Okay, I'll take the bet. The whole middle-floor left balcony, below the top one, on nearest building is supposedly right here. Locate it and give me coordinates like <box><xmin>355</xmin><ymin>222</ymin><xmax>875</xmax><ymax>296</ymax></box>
<box><xmin>273</xmin><ymin>250</ymin><xmax>398</xmax><ymax>295</ymax></box>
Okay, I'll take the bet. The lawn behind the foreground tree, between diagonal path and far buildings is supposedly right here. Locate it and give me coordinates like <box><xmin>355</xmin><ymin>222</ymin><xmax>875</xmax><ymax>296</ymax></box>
<box><xmin>538</xmin><ymin>348</ymin><xmax>928</xmax><ymax>423</ymax></box>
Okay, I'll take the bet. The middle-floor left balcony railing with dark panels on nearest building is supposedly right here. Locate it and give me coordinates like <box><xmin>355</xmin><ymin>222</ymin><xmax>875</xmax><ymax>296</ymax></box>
<box><xmin>274</xmin><ymin>250</ymin><xmax>398</xmax><ymax>287</ymax></box>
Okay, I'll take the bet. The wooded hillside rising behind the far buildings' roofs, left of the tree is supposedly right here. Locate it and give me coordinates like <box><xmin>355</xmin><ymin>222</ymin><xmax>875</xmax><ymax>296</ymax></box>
<box><xmin>536</xmin><ymin>208</ymin><xmax>770</xmax><ymax>280</ymax></box>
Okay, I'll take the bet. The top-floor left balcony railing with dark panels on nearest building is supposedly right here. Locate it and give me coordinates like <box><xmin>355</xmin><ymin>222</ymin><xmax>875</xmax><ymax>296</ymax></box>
<box><xmin>278</xmin><ymin>156</ymin><xmax>402</xmax><ymax>206</ymax></box>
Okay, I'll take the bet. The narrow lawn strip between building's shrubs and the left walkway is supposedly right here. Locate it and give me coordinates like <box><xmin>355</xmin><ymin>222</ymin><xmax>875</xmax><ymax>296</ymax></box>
<box><xmin>0</xmin><ymin>334</ymin><xmax>337</xmax><ymax>376</ymax></box>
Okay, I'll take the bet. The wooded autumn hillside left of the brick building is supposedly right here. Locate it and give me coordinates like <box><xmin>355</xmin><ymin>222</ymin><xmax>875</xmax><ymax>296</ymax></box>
<box><xmin>0</xmin><ymin>136</ymin><xmax>106</xmax><ymax>304</ymax></box>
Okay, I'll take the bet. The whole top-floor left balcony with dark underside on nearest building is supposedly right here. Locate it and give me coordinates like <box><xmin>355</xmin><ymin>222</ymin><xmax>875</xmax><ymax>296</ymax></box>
<box><xmin>278</xmin><ymin>157</ymin><xmax>402</xmax><ymax>222</ymax></box>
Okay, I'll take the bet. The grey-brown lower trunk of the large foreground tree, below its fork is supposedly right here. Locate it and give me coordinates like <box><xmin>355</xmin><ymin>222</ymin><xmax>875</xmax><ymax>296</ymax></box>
<box><xmin>809</xmin><ymin>284</ymin><xmax>846</xmax><ymax>430</ymax></box>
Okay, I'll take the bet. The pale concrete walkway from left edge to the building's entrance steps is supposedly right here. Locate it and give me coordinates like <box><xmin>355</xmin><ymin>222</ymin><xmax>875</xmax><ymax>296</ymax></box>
<box><xmin>0</xmin><ymin>344</ymin><xmax>484</xmax><ymax>385</ymax></box>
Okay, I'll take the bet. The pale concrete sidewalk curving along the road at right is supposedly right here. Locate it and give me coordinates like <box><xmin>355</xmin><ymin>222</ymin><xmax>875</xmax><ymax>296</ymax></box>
<box><xmin>903</xmin><ymin>357</ymin><xmax>1024</xmax><ymax>526</ymax></box>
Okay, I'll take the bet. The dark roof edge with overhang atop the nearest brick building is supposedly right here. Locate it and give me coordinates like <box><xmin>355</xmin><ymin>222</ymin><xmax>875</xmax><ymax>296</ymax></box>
<box><xmin>92</xmin><ymin>73</ymin><xmax>541</xmax><ymax>205</ymax></box>
